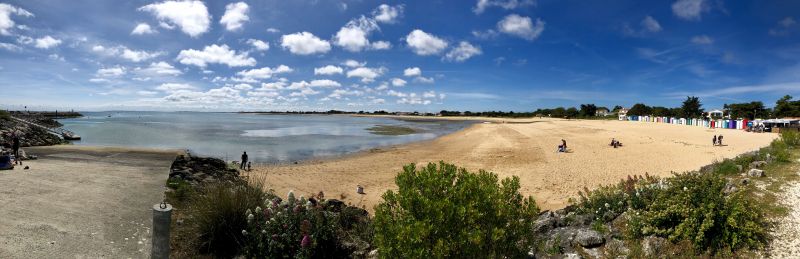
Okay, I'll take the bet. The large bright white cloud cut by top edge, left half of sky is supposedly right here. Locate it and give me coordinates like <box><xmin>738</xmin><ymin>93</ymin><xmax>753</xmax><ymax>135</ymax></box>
<box><xmin>139</xmin><ymin>0</ymin><xmax>211</xmax><ymax>37</ymax></box>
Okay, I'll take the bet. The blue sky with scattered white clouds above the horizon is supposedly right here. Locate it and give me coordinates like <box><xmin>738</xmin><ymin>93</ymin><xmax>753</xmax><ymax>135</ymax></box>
<box><xmin>0</xmin><ymin>0</ymin><xmax>800</xmax><ymax>112</ymax></box>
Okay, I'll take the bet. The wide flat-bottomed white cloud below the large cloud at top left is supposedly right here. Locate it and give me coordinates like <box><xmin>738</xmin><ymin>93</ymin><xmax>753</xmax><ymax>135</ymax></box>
<box><xmin>176</xmin><ymin>44</ymin><xmax>256</xmax><ymax>68</ymax></box>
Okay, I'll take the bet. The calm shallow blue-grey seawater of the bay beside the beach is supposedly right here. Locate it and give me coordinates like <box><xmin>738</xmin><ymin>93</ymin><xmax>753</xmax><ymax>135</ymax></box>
<box><xmin>60</xmin><ymin>112</ymin><xmax>471</xmax><ymax>163</ymax></box>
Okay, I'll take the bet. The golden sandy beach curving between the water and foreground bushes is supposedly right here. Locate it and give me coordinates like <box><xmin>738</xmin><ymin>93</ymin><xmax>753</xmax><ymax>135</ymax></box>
<box><xmin>253</xmin><ymin>117</ymin><xmax>778</xmax><ymax>211</ymax></box>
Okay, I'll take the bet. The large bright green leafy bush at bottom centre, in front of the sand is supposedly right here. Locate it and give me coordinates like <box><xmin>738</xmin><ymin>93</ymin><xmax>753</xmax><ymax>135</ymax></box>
<box><xmin>374</xmin><ymin>162</ymin><xmax>539</xmax><ymax>258</ymax></box>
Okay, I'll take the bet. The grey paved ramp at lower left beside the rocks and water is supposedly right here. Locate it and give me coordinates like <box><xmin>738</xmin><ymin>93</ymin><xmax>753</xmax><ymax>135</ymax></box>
<box><xmin>0</xmin><ymin>146</ymin><xmax>176</xmax><ymax>258</ymax></box>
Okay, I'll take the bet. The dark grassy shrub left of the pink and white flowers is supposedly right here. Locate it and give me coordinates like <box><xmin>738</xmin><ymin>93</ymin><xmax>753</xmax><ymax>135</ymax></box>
<box><xmin>190</xmin><ymin>182</ymin><xmax>272</xmax><ymax>257</ymax></box>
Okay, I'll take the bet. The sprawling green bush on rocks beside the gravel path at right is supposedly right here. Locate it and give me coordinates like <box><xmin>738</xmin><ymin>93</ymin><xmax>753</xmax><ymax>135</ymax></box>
<box><xmin>632</xmin><ymin>173</ymin><xmax>767</xmax><ymax>252</ymax></box>
